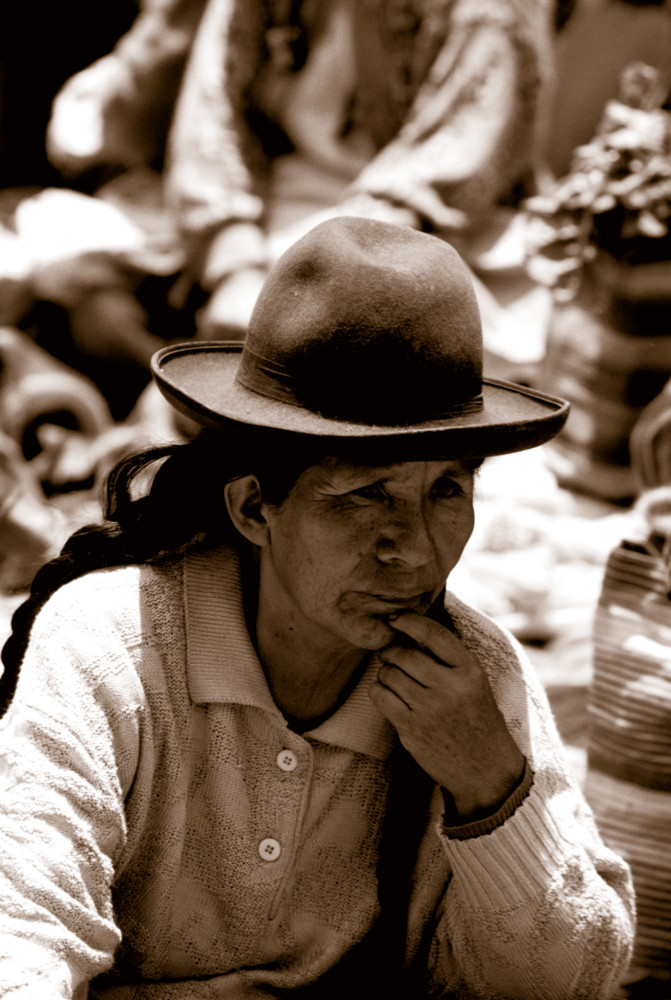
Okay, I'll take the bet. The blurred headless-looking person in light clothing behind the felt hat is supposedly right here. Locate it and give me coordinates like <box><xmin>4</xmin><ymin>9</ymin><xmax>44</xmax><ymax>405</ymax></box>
<box><xmin>165</xmin><ymin>0</ymin><xmax>557</xmax><ymax>337</ymax></box>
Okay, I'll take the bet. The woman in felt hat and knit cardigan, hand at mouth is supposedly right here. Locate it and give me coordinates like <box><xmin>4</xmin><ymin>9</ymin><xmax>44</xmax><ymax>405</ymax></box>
<box><xmin>0</xmin><ymin>218</ymin><xmax>632</xmax><ymax>1000</ymax></box>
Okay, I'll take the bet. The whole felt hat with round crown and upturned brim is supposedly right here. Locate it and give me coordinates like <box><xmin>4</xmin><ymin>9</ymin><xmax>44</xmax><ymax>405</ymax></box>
<box><xmin>152</xmin><ymin>217</ymin><xmax>569</xmax><ymax>460</ymax></box>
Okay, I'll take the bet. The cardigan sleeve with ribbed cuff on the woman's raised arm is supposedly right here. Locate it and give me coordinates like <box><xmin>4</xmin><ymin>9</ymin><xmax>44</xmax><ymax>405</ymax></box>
<box><xmin>422</xmin><ymin>596</ymin><xmax>634</xmax><ymax>1000</ymax></box>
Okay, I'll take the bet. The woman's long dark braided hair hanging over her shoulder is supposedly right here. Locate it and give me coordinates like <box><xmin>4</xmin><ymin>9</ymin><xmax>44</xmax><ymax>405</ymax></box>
<box><xmin>0</xmin><ymin>430</ymin><xmax>315</xmax><ymax>717</ymax></box>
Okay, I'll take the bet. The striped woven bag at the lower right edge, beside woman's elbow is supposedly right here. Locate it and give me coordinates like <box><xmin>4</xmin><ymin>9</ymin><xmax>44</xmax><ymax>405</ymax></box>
<box><xmin>585</xmin><ymin>538</ymin><xmax>671</xmax><ymax>977</ymax></box>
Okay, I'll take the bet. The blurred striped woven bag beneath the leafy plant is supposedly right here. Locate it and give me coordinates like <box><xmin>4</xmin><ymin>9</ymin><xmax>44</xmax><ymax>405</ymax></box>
<box><xmin>539</xmin><ymin>252</ymin><xmax>671</xmax><ymax>500</ymax></box>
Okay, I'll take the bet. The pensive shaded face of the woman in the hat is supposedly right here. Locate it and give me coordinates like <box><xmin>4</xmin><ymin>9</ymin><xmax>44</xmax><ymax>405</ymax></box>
<box><xmin>259</xmin><ymin>458</ymin><xmax>473</xmax><ymax>649</ymax></box>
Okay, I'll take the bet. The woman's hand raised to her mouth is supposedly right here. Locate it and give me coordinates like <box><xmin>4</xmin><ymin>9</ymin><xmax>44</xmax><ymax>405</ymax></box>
<box><xmin>371</xmin><ymin>612</ymin><xmax>525</xmax><ymax>821</ymax></box>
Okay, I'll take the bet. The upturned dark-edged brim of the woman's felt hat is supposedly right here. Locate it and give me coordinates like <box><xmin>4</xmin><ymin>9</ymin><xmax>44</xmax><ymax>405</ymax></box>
<box><xmin>151</xmin><ymin>341</ymin><xmax>569</xmax><ymax>457</ymax></box>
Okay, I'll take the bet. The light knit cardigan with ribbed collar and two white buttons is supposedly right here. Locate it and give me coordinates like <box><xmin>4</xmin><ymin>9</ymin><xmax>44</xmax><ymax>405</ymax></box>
<box><xmin>0</xmin><ymin>548</ymin><xmax>633</xmax><ymax>1000</ymax></box>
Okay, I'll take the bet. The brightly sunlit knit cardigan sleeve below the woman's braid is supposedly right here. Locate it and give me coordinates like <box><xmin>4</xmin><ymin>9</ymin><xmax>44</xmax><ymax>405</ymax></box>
<box><xmin>0</xmin><ymin>581</ymin><xmax>146</xmax><ymax>1000</ymax></box>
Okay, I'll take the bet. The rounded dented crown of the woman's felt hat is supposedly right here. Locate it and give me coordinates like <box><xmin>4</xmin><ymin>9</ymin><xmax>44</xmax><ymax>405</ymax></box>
<box><xmin>237</xmin><ymin>217</ymin><xmax>482</xmax><ymax>426</ymax></box>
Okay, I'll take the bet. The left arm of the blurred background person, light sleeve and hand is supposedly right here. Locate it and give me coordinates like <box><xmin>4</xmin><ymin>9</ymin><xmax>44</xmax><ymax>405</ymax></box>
<box><xmin>165</xmin><ymin>0</ymin><xmax>267</xmax><ymax>290</ymax></box>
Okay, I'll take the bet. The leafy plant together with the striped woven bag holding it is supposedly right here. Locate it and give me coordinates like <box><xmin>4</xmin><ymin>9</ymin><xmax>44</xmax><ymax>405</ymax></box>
<box><xmin>525</xmin><ymin>63</ymin><xmax>671</xmax><ymax>501</ymax></box>
